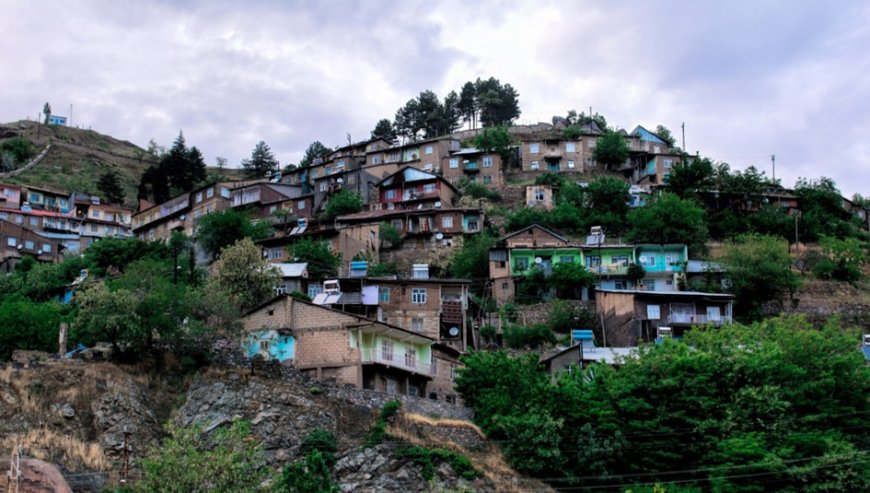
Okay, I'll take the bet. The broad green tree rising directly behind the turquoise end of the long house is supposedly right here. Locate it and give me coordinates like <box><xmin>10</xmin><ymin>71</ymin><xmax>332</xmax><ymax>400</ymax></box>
<box><xmin>628</xmin><ymin>193</ymin><xmax>707</xmax><ymax>245</ymax></box>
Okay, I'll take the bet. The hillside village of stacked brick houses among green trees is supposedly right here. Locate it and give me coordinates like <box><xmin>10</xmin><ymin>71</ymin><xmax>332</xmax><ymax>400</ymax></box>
<box><xmin>0</xmin><ymin>109</ymin><xmax>870</xmax><ymax>490</ymax></box>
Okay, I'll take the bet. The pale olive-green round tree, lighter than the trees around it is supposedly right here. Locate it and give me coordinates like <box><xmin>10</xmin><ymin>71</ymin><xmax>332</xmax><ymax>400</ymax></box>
<box><xmin>211</xmin><ymin>238</ymin><xmax>280</xmax><ymax>312</ymax></box>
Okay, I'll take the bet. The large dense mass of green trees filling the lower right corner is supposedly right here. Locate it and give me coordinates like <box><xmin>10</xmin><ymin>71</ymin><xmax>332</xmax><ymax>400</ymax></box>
<box><xmin>456</xmin><ymin>318</ymin><xmax>870</xmax><ymax>492</ymax></box>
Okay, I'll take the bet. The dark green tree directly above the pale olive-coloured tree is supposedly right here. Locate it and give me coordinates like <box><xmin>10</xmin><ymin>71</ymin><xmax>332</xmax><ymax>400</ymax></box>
<box><xmin>196</xmin><ymin>209</ymin><xmax>273</xmax><ymax>259</ymax></box>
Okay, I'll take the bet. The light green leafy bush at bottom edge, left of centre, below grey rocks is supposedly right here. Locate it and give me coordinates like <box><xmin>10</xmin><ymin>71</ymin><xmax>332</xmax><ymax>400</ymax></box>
<box><xmin>132</xmin><ymin>421</ymin><xmax>272</xmax><ymax>493</ymax></box>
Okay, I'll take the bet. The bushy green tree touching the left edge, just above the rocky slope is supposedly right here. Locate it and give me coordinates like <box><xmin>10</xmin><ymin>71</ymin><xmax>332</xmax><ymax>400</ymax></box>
<box><xmin>0</xmin><ymin>299</ymin><xmax>69</xmax><ymax>361</ymax></box>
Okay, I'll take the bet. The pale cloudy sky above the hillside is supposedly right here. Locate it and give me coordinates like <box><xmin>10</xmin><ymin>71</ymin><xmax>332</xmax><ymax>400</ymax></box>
<box><xmin>0</xmin><ymin>0</ymin><xmax>870</xmax><ymax>196</ymax></box>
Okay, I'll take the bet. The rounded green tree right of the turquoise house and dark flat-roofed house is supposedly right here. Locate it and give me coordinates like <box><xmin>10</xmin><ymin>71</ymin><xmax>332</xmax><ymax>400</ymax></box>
<box><xmin>721</xmin><ymin>234</ymin><xmax>800</xmax><ymax>320</ymax></box>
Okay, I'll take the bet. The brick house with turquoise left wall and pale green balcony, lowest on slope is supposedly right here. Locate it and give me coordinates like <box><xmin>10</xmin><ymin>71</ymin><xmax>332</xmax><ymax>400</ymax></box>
<box><xmin>242</xmin><ymin>296</ymin><xmax>445</xmax><ymax>396</ymax></box>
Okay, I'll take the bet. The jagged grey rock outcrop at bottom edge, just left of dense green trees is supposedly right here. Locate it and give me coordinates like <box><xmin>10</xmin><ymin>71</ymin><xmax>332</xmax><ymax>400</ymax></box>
<box><xmin>334</xmin><ymin>444</ymin><xmax>493</xmax><ymax>493</ymax></box>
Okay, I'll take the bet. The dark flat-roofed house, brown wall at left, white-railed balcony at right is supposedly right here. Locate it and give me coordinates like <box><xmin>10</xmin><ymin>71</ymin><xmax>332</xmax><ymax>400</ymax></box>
<box><xmin>595</xmin><ymin>289</ymin><xmax>734</xmax><ymax>346</ymax></box>
